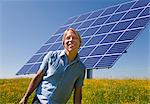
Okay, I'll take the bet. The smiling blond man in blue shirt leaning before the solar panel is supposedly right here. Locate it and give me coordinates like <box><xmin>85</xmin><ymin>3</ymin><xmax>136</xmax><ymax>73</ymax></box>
<box><xmin>19</xmin><ymin>28</ymin><xmax>85</xmax><ymax>104</ymax></box>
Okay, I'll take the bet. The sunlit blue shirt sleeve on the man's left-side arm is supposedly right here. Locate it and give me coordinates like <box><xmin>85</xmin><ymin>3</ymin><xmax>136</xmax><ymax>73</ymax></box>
<box><xmin>39</xmin><ymin>52</ymin><xmax>52</xmax><ymax>72</ymax></box>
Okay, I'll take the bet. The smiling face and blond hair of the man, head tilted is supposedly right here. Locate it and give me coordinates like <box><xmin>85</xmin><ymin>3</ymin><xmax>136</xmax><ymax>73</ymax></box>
<box><xmin>64</xmin><ymin>30</ymin><xmax>80</xmax><ymax>52</ymax></box>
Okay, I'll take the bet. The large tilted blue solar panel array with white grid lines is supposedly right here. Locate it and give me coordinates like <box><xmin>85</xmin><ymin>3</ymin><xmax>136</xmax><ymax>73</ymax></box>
<box><xmin>17</xmin><ymin>0</ymin><xmax>150</xmax><ymax>75</ymax></box>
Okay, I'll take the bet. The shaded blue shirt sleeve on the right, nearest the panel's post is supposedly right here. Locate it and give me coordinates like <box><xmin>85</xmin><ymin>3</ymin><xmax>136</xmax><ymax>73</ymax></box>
<box><xmin>75</xmin><ymin>69</ymin><xmax>85</xmax><ymax>87</ymax></box>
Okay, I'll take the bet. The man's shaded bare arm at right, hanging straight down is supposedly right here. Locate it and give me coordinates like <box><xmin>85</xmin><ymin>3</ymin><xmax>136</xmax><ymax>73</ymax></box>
<box><xmin>73</xmin><ymin>87</ymin><xmax>82</xmax><ymax>104</ymax></box>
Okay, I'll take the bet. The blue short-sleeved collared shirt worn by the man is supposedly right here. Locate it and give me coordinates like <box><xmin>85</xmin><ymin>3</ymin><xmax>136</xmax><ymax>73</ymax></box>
<box><xmin>36</xmin><ymin>50</ymin><xmax>85</xmax><ymax>104</ymax></box>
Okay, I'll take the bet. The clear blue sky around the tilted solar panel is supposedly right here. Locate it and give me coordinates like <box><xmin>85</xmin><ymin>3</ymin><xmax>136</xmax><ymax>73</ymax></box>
<box><xmin>0</xmin><ymin>0</ymin><xmax>150</xmax><ymax>78</ymax></box>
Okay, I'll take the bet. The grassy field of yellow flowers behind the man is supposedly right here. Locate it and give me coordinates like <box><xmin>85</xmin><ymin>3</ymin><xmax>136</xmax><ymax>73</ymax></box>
<box><xmin>0</xmin><ymin>78</ymin><xmax>150</xmax><ymax>104</ymax></box>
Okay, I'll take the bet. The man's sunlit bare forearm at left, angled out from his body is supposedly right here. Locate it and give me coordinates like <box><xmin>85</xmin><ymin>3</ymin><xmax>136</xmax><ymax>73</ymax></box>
<box><xmin>19</xmin><ymin>70</ymin><xmax>45</xmax><ymax>104</ymax></box>
